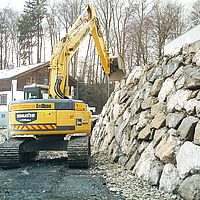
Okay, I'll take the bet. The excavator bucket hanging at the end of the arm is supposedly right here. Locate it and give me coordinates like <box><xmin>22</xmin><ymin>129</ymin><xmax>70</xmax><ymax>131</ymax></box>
<box><xmin>109</xmin><ymin>56</ymin><xmax>126</xmax><ymax>81</ymax></box>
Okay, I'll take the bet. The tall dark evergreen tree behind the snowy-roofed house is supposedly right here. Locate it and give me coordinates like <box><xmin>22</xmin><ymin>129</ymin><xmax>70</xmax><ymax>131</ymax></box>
<box><xmin>18</xmin><ymin>0</ymin><xmax>47</xmax><ymax>64</ymax></box>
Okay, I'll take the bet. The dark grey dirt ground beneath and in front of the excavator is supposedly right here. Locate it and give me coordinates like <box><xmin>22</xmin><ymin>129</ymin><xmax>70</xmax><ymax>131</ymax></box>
<box><xmin>0</xmin><ymin>154</ymin><xmax>124</xmax><ymax>200</ymax></box>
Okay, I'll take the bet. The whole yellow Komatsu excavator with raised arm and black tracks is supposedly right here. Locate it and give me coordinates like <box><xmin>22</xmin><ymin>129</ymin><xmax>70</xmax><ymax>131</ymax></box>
<box><xmin>0</xmin><ymin>5</ymin><xmax>125</xmax><ymax>168</ymax></box>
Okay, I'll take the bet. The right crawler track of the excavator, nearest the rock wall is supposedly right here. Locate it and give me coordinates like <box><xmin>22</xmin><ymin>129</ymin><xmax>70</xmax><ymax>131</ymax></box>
<box><xmin>67</xmin><ymin>136</ymin><xmax>90</xmax><ymax>168</ymax></box>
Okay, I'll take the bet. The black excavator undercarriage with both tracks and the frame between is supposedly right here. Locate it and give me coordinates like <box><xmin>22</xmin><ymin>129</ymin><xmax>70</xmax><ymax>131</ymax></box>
<box><xmin>0</xmin><ymin>135</ymin><xmax>90</xmax><ymax>169</ymax></box>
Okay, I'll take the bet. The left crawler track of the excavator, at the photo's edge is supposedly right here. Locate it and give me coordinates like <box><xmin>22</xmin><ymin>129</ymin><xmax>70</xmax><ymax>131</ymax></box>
<box><xmin>0</xmin><ymin>138</ymin><xmax>24</xmax><ymax>169</ymax></box>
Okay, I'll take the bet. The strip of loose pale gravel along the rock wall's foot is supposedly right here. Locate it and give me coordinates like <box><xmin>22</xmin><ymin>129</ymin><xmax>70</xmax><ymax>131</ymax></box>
<box><xmin>91</xmin><ymin>152</ymin><xmax>182</xmax><ymax>200</ymax></box>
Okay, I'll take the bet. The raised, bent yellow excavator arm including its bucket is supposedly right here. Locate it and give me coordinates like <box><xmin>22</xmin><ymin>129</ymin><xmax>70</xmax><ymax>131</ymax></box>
<box><xmin>49</xmin><ymin>5</ymin><xmax>125</xmax><ymax>99</ymax></box>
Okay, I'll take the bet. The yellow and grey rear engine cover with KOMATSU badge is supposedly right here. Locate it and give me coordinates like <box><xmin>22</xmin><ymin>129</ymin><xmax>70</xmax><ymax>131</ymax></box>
<box><xmin>9</xmin><ymin>99</ymin><xmax>91</xmax><ymax>135</ymax></box>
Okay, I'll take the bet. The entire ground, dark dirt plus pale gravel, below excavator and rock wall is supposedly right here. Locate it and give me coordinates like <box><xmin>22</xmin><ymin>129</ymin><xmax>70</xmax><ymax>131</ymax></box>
<box><xmin>0</xmin><ymin>133</ymin><xmax>182</xmax><ymax>200</ymax></box>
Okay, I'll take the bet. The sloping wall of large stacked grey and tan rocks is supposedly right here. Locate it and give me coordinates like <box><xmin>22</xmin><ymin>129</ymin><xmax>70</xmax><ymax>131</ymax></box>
<box><xmin>91</xmin><ymin>42</ymin><xmax>200</xmax><ymax>199</ymax></box>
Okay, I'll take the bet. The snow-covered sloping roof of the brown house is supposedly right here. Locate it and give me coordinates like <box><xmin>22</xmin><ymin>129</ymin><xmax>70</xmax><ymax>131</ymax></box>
<box><xmin>0</xmin><ymin>61</ymin><xmax>50</xmax><ymax>80</ymax></box>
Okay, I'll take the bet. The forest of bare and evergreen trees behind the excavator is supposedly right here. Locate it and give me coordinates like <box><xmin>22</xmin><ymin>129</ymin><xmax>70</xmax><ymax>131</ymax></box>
<box><xmin>0</xmin><ymin>0</ymin><xmax>200</xmax><ymax>112</ymax></box>
